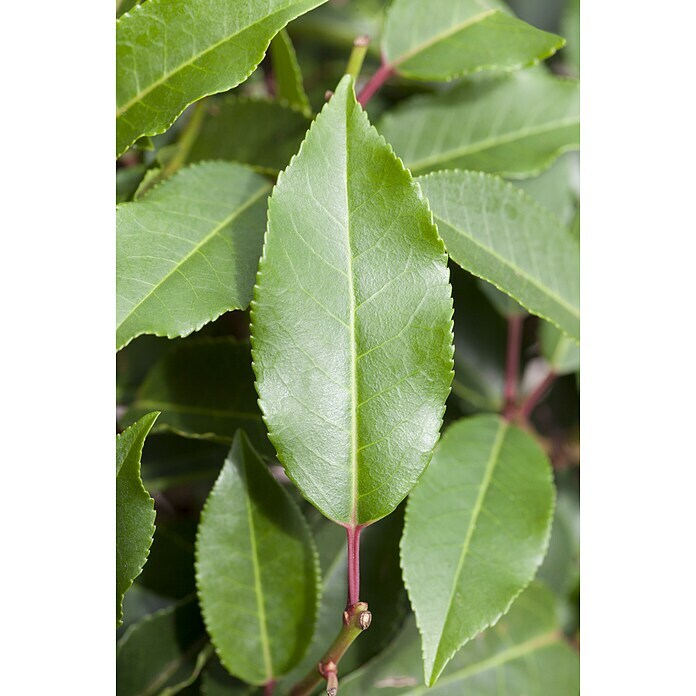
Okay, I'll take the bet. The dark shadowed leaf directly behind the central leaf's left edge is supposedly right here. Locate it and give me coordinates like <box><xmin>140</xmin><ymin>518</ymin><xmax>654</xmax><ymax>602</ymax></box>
<box><xmin>122</xmin><ymin>337</ymin><xmax>273</xmax><ymax>454</ymax></box>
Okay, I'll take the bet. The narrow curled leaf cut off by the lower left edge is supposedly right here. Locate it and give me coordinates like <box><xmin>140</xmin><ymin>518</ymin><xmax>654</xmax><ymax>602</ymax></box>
<box><xmin>116</xmin><ymin>412</ymin><xmax>159</xmax><ymax>626</ymax></box>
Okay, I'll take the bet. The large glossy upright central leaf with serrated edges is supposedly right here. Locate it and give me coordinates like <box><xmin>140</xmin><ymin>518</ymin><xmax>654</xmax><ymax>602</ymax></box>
<box><xmin>252</xmin><ymin>76</ymin><xmax>452</xmax><ymax>525</ymax></box>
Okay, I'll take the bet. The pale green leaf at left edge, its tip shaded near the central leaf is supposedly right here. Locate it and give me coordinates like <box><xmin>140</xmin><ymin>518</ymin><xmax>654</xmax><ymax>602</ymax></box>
<box><xmin>116</xmin><ymin>160</ymin><xmax>271</xmax><ymax>350</ymax></box>
